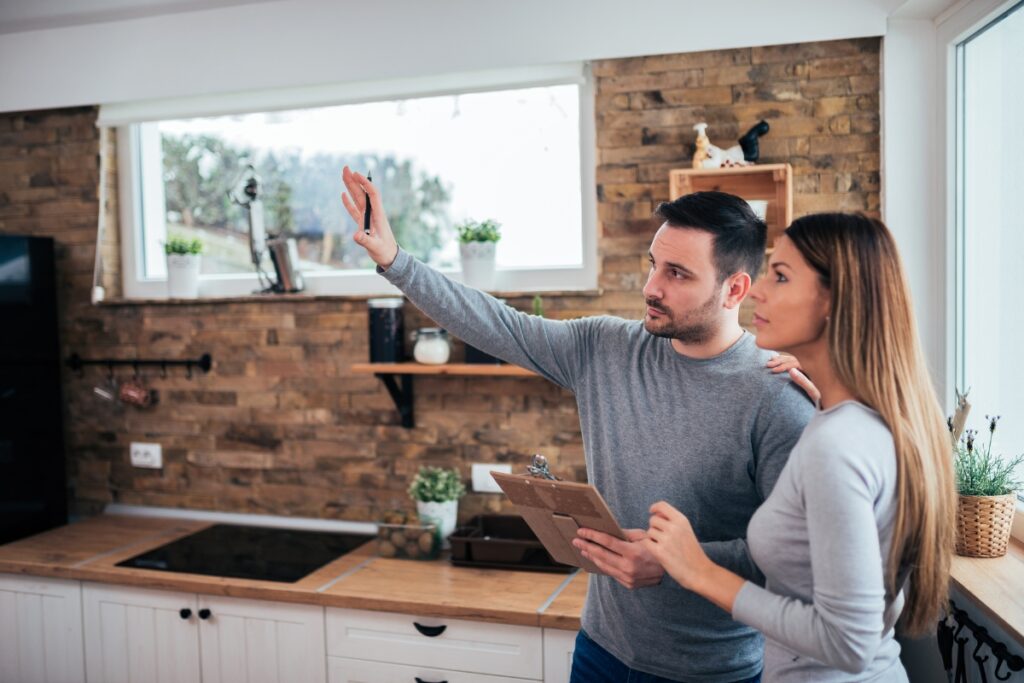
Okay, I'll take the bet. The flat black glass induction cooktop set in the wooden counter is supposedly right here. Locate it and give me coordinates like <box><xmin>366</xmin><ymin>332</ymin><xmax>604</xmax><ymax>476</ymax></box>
<box><xmin>118</xmin><ymin>524</ymin><xmax>373</xmax><ymax>584</ymax></box>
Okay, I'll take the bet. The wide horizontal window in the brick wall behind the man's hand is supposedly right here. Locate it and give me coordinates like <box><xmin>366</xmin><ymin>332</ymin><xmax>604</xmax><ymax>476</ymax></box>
<box><xmin>100</xmin><ymin>66</ymin><xmax>597</xmax><ymax>297</ymax></box>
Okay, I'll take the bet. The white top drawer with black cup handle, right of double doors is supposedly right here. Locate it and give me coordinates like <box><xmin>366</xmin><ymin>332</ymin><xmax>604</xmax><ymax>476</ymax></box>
<box><xmin>327</xmin><ymin>607</ymin><xmax>544</xmax><ymax>680</ymax></box>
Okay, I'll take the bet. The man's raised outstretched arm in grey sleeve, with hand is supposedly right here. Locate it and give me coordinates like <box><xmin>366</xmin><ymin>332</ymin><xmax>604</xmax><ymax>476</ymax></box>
<box><xmin>342</xmin><ymin>166</ymin><xmax>591</xmax><ymax>389</ymax></box>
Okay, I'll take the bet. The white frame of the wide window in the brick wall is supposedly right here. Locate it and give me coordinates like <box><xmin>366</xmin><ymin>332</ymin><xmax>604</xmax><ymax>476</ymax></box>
<box><xmin>107</xmin><ymin>62</ymin><xmax>598</xmax><ymax>299</ymax></box>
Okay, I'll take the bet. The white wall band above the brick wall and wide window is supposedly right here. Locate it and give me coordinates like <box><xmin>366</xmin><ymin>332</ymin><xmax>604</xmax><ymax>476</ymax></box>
<box><xmin>0</xmin><ymin>0</ymin><xmax>898</xmax><ymax>112</ymax></box>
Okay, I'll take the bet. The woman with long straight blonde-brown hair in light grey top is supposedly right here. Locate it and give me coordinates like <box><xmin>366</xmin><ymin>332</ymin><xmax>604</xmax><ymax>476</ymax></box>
<box><xmin>645</xmin><ymin>214</ymin><xmax>955</xmax><ymax>682</ymax></box>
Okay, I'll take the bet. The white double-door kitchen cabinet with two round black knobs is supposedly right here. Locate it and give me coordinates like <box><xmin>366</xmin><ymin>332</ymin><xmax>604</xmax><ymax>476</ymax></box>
<box><xmin>83</xmin><ymin>584</ymin><xmax>327</xmax><ymax>683</ymax></box>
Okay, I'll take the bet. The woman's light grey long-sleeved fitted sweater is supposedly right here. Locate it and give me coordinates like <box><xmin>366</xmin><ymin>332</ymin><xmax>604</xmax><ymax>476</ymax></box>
<box><xmin>732</xmin><ymin>401</ymin><xmax>906</xmax><ymax>683</ymax></box>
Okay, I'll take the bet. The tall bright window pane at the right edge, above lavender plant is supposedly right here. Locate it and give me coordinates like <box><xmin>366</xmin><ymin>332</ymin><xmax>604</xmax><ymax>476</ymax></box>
<box><xmin>955</xmin><ymin>3</ymin><xmax>1024</xmax><ymax>491</ymax></box>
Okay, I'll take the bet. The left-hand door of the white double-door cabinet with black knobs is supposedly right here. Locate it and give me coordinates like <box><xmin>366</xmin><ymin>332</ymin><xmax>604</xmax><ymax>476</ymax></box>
<box><xmin>82</xmin><ymin>584</ymin><xmax>200</xmax><ymax>683</ymax></box>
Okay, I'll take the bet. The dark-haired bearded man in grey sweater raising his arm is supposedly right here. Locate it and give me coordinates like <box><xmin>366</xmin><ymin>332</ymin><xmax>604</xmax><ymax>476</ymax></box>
<box><xmin>342</xmin><ymin>167</ymin><xmax>813</xmax><ymax>683</ymax></box>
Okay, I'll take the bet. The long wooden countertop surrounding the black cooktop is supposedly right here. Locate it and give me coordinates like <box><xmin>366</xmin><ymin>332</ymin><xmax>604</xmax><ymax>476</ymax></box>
<box><xmin>0</xmin><ymin>515</ymin><xmax>586</xmax><ymax>630</ymax></box>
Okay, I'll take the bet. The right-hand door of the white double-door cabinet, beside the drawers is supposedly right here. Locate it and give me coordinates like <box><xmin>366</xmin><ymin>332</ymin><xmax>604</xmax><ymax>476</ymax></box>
<box><xmin>199</xmin><ymin>595</ymin><xmax>327</xmax><ymax>683</ymax></box>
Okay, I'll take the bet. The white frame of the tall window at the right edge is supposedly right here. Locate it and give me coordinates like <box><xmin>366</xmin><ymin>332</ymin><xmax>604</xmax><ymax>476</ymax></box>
<box><xmin>935</xmin><ymin>0</ymin><xmax>1024</xmax><ymax>518</ymax></box>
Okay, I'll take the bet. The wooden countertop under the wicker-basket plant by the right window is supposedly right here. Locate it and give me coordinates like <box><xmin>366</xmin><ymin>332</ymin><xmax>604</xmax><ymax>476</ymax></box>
<box><xmin>950</xmin><ymin>540</ymin><xmax>1024</xmax><ymax>644</ymax></box>
